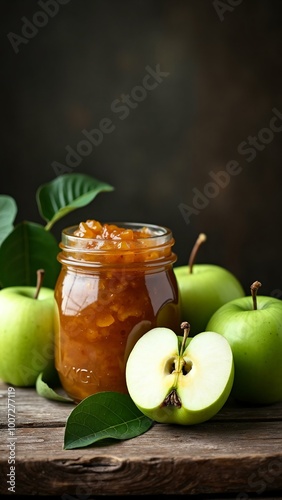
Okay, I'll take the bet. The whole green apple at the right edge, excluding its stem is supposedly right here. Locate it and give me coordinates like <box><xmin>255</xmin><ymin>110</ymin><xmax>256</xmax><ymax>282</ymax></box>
<box><xmin>206</xmin><ymin>296</ymin><xmax>282</xmax><ymax>404</ymax></box>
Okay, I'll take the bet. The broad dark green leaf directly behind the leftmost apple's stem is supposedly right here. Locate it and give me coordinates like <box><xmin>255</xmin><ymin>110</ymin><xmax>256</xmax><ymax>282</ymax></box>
<box><xmin>0</xmin><ymin>222</ymin><xmax>60</xmax><ymax>288</ymax></box>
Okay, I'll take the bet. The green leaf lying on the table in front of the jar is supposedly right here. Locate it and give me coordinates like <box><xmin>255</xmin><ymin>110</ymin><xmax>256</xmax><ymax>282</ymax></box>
<box><xmin>64</xmin><ymin>391</ymin><xmax>154</xmax><ymax>450</ymax></box>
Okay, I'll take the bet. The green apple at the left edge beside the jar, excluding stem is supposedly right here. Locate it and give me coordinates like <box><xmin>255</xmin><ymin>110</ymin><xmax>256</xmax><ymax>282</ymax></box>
<box><xmin>0</xmin><ymin>286</ymin><xmax>55</xmax><ymax>387</ymax></box>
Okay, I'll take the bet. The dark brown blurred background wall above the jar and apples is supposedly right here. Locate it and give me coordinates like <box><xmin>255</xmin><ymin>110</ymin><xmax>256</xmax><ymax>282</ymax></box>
<box><xmin>1</xmin><ymin>0</ymin><xmax>282</xmax><ymax>298</ymax></box>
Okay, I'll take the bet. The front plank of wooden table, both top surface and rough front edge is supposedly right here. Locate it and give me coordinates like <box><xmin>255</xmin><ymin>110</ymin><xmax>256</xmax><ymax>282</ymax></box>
<box><xmin>0</xmin><ymin>422</ymin><xmax>282</xmax><ymax>495</ymax></box>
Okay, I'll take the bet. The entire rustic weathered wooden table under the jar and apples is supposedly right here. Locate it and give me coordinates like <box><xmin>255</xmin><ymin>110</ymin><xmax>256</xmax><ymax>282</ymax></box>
<box><xmin>0</xmin><ymin>383</ymin><xmax>282</xmax><ymax>500</ymax></box>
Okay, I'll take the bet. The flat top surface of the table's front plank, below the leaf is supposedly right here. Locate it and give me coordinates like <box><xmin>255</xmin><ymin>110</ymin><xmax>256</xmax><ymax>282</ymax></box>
<box><xmin>0</xmin><ymin>421</ymin><xmax>282</xmax><ymax>458</ymax></box>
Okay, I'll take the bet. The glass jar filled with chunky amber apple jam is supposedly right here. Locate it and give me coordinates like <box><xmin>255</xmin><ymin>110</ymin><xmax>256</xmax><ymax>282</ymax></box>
<box><xmin>55</xmin><ymin>220</ymin><xmax>180</xmax><ymax>402</ymax></box>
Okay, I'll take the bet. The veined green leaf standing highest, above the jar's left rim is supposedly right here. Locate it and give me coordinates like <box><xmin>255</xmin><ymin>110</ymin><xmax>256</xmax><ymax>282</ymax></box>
<box><xmin>36</xmin><ymin>173</ymin><xmax>114</xmax><ymax>230</ymax></box>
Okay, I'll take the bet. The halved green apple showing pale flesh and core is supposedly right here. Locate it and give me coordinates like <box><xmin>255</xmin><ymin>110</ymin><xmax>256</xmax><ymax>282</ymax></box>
<box><xmin>125</xmin><ymin>323</ymin><xmax>234</xmax><ymax>425</ymax></box>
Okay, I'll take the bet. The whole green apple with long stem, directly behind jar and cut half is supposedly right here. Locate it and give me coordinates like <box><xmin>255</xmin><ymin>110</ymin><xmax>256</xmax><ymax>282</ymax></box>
<box><xmin>174</xmin><ymin>233</ymin><xmax>246</xmax><ymax>336</ymax></box>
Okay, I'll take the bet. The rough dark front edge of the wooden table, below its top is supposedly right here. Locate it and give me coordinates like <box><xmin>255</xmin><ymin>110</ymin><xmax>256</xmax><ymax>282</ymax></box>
<box><xmin>1</xmin><ymin>456</ymin><xmax>282</xmax><ymax>499</ymax></box>
